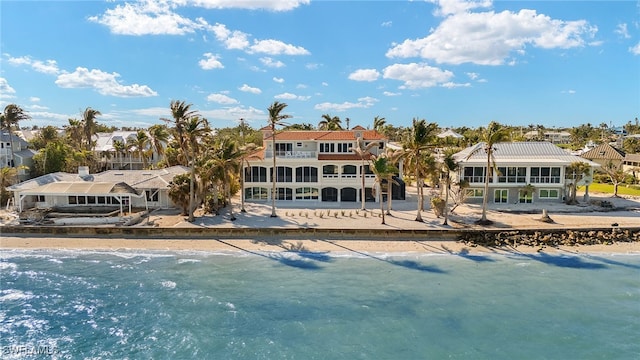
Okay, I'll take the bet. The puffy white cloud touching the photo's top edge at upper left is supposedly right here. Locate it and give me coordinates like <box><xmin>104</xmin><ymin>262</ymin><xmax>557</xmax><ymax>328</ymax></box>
<box><xmin>89</xmin><ymin>0</ymin><xmax>202</xmax><ymax>35</ymax></box>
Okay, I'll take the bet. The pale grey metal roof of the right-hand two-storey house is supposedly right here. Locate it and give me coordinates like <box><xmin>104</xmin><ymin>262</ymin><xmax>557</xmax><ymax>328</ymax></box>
<box><xmin>454</xmin><ymin>141</ymin><xmax>600</xmax><ymax>167</ymax></box>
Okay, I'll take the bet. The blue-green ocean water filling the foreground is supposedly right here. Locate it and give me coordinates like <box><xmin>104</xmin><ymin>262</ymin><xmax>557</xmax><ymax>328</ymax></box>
<box><xmin>0</xmin><ymin>250</ymin><xmax>640</xmax><ymax>359</ymax></box>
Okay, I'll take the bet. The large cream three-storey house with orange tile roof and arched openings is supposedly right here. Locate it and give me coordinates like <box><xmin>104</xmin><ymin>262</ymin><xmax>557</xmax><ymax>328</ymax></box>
<box><xmin>242</xmin><ymin>126</ymin><xmax>405</xmax><ymax>203</ymax></box>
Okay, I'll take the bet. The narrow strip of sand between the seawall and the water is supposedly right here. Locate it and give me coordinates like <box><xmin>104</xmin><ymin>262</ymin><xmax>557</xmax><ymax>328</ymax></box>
<box><xmin>0</xmin><ymin>236</ymin><xmax>640</xmax><ymax>255</ymax></box>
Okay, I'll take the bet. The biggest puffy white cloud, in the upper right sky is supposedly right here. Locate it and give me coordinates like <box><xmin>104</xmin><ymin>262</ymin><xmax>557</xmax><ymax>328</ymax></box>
<box><xmin>386</xmin><ymin>7</ymin><xmax>597</xmax><ymax>65</ymax></box>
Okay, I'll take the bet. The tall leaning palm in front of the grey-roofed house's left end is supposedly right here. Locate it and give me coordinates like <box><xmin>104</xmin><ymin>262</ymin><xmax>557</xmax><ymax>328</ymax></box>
<box><xmin>467</xmin><ymin>121</ymin><xmax>509</xmax><ymax>225</ymax></box>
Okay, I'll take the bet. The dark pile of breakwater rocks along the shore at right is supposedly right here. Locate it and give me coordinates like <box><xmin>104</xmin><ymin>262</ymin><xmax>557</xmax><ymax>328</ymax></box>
<box><xmin>458</xmin><ymin>227</ymin><xmax>640</xmax><ymax>247</ymax></box>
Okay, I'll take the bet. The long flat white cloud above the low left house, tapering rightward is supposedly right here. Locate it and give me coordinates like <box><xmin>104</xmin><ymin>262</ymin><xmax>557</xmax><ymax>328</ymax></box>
<box><xmin>55</xmin><ymin>67</ymin><xmax>158</xmax><ymax>97</ymax></box>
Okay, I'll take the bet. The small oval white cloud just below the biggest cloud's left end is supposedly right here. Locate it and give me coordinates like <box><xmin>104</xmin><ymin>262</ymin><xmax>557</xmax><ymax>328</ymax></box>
<box><xmin>383</xmin><ymin>63</ymin><xmax>453</xmax><ymax>89</ymax></box>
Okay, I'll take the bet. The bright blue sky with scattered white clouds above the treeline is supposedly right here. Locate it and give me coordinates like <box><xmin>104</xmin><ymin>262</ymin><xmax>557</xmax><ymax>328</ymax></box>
<box><xmin>0</xmin><ymin>0</ymin><xmax>640</xmax><ymax>128</ymax></box>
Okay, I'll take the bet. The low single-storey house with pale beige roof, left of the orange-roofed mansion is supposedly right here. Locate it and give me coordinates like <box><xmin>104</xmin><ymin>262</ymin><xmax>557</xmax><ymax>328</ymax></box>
<box><xmin>8</xmin><ymin>166</ymin><xmax>189</xmax><ymax>213</ymax></box>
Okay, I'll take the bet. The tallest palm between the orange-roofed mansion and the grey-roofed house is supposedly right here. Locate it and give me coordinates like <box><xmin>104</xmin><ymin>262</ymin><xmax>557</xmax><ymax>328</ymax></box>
<box><xmin>402</xmin><ymin>118</ymin><xmax>438</xmax><ymax>222</ymax></box>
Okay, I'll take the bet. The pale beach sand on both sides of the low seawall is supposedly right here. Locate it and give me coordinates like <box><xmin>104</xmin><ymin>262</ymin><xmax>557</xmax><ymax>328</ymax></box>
<box><xmin>0</xmin><ymin>190</ymin><xmax>640</xmax><ymax>254</ymax></box>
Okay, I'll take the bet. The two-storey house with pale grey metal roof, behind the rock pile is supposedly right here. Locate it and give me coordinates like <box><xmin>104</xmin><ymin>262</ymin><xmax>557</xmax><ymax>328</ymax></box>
<box><xmin>455</xmin><ymin>141</ymin><xmax>600</xmax><ymax>204</ymax></box>
